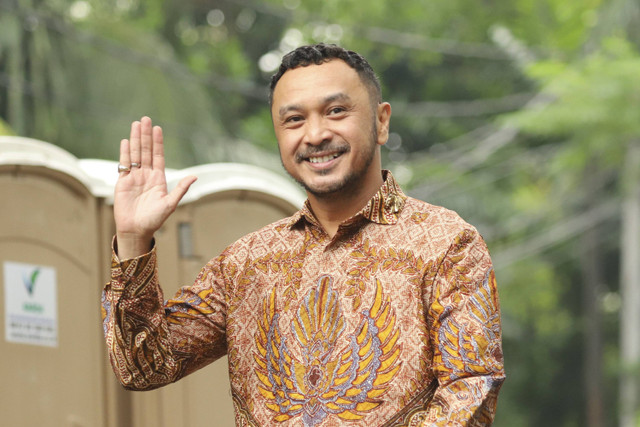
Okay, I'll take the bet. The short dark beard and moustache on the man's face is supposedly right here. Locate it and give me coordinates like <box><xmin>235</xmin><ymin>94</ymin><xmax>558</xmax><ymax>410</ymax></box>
<box><xmin>280</xmin><ymin>119</ymin><xmax>378</xmax><ymax>199</ymax></box>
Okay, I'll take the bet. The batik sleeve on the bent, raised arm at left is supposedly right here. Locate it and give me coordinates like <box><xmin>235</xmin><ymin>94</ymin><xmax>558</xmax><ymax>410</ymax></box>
<box><xmin>102</xmin><ymin>241</ymin><xmax>226</xmax><ymax>390</ymax></box>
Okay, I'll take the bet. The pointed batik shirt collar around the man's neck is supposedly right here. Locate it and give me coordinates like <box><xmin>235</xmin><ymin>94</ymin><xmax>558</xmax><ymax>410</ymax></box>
<box><xmin>289</xmin><ymin>170</ymin><xmax>407</xmax><ymax>231</ymax></box>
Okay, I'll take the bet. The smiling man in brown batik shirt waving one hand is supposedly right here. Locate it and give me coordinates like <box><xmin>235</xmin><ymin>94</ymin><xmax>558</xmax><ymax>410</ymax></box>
<box><xmin>103</xmin><ymin>44</ymin><xmax>504</xmax><ymax>426</ymax></box>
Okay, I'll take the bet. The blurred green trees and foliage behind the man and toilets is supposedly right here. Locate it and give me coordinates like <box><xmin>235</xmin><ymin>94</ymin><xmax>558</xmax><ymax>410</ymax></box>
<box><xmin>0</xmin><ymin>0</ymin><xmax>640</xmax><ymax>427</ymax></box>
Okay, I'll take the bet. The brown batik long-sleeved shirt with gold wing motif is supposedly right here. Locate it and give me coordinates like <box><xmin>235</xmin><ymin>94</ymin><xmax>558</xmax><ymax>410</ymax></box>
<box><xmin>102</xmin><ymin>172</ymin><xmax>504</xmax><ymax>427</ymax></box>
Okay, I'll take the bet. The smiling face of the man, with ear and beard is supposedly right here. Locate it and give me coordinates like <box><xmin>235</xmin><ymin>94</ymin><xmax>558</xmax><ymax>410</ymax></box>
<box><xmin>271</xmin><ymin>60</ymin><xmax>390</xmax><ymax>197</ymax></box>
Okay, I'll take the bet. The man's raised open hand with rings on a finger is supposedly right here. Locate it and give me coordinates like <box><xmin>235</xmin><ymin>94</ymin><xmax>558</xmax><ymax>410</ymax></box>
<box><xmin>113</xmin><ymin>117</ymin><xmax>196</xmax><ymax>259</ymax></box>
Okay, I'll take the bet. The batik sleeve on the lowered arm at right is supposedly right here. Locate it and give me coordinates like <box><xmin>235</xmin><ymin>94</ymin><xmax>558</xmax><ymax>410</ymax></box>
<box><xmin>422</xmin><ymin>229</ymin><xmax>505</xmax><ymax>426</ymax></box>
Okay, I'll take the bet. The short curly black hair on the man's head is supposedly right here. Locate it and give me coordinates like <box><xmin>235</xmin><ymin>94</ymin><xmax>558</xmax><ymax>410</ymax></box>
<box><xmin>269</xmin><ymin>43</ymin><xmax>382</xmax><ymax>104</ymax></box>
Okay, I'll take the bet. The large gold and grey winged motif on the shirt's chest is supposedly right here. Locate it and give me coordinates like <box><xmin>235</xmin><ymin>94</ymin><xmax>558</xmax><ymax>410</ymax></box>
<box><xmin>254</xmin><ymin>276</ymin><xmax>402</xmax><ymax>426</ymax></box>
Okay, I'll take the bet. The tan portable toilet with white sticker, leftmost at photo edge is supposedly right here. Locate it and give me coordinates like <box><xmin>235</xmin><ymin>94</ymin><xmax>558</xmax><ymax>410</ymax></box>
<box><xmin>0</xmin><ymin>137</ymin><xmax>110</xmax><ymax>427</ymax></box>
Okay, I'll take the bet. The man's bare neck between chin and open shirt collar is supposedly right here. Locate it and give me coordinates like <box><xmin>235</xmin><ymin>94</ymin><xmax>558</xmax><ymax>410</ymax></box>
<box><xmin>307</xmin><ymin>174</ymin><xmax>384</xmax><ymax>241</ymax></box>
